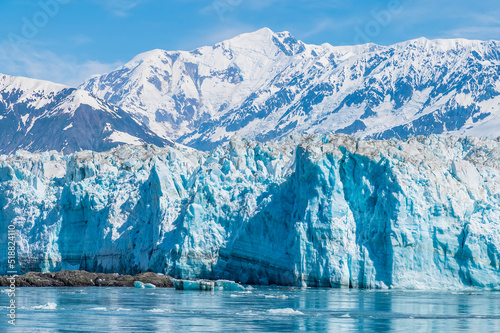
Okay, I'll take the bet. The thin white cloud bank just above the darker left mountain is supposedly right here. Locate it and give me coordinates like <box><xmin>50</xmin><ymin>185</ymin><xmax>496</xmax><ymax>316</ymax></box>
<box><xmin>0</xmin><ymin>42</ymin><xmax>121</xmax><ymax>87</ymax></box>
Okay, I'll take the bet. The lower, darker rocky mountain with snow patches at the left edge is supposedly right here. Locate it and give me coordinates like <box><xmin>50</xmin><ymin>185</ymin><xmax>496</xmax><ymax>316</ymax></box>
<box><xmin>0</xmin><ymin>75</ymin><xmax>170</xmax><ymax>153</ymax></box>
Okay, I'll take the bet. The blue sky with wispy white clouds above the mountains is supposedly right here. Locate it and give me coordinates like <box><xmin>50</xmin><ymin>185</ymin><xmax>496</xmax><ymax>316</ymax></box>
<box><xmin>0</xmin><ymin>0</ymin><xmax>500</xmax><ymax>86</ymax></box>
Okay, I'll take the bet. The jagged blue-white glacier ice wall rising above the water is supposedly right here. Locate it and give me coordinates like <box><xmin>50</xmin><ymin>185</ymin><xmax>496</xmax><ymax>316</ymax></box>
<box><xmin>0</xmin><ymin>135</ymin><xmax>500</xmax><ymax>289</ymax></box>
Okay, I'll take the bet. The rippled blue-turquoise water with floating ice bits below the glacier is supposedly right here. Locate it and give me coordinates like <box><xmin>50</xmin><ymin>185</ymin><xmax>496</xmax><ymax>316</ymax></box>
<box><xmin>0</xmin><ymin>288</ymin><xmax>500</xmax><ymax>332</ymax></box>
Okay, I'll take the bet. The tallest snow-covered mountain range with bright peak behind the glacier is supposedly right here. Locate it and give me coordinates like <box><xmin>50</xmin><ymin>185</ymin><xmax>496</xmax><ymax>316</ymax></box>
<box><xmin>81</xmin><ymin>28</ymin><xmax>500</xmax><ymax>149</ymax></box>
